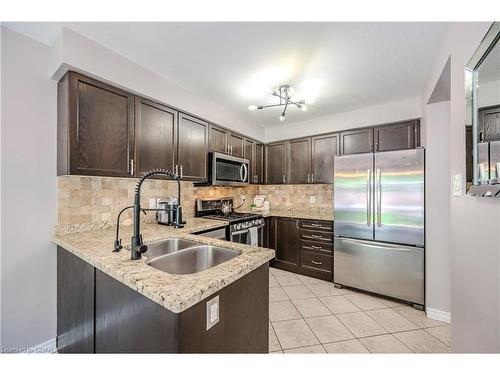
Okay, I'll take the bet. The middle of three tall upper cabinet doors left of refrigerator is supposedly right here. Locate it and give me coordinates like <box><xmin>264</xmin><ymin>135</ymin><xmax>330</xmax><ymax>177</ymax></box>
<box><xmin>287</xmin><ymin>138</ymin><xmax>311</xmax><ymax>184</ymax></box>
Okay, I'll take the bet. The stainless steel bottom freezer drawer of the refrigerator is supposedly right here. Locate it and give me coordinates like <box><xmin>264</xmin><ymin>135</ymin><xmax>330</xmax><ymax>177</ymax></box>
<box><xmin>333</xmin><ymin>237</ymin><xmax>424</xmax><ymax>305</ymax></box>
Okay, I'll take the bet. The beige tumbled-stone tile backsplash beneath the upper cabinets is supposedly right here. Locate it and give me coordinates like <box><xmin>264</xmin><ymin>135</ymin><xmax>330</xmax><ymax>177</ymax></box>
<box><xmin>57</xmin><ymin>176</ymin><xmax>333</xmax><ymax>227</ymax></box>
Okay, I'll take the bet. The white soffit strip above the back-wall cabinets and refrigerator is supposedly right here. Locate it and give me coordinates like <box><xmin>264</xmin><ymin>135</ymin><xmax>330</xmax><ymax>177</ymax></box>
<box><xmin>265</xmin><ymin>97</ymin><xmax>422</xmax><ymax>142</ymax></box>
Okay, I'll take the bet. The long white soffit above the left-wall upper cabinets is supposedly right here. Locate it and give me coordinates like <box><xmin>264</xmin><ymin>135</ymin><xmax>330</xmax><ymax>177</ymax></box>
<box><xmin>50</xmin><ymin>28</ymin><xmax>264</xmax><ymax>141</ymax></box>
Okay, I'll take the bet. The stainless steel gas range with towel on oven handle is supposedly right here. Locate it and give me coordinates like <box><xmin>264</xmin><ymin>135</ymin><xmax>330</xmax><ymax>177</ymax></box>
<box><xmin>196</xmin><ymin>197</ymin><xmax>264</xmax><ymax>246</ymax></box>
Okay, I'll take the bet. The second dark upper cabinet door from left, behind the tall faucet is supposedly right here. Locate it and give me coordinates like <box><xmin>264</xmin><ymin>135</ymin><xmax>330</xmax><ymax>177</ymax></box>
<box><xmin>135</xmin><ymin>97</ymin><xmax>177</xmax><ymax>176</ymax></box>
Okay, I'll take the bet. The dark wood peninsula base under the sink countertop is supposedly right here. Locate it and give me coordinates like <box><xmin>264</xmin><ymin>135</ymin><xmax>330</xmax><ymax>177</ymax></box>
<box><xmin>57</xmin><ymin>247</ymin><xmax>269</xmax><ymax>353</ymax></box>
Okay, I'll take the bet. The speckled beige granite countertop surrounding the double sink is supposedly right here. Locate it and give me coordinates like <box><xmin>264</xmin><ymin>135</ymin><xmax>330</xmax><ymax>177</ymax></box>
<box><xmin>54</xmin><ymin>218</ymin><xmax>274</xmax><ymax>313</ymax></box>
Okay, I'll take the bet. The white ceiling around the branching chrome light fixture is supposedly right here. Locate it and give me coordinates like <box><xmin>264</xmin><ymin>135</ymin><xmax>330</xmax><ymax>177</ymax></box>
<box><xmin>4</xmin><ymin>22</ymin><xmax>446</xmax><ymax>127</ymax></box>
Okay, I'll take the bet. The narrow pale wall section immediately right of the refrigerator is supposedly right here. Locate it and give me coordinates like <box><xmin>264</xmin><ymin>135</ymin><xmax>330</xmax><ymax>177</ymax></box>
<box><xmin>424</xmin><ymin>100</ymin><xmax>451</xmax><ymax>320</ymax></box>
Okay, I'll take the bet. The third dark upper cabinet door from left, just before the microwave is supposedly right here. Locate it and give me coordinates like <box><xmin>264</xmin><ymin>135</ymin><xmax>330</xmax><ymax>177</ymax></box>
<box><xmin>176</xmin><ymin>113</ymin><xmax>208</xmax><ymax>180</ymax></box>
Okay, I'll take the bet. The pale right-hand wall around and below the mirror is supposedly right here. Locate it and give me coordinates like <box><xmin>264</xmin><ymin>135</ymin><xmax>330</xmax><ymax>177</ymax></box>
<box><xmin>422</xmin><ymin>23</ymin><xmax>500</xmax><ymax>352</ymax></box>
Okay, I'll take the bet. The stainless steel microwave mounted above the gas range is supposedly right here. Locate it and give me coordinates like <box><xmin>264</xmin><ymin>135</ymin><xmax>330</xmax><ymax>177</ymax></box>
<box><xmin>196</xmin><ymin>152</ymin><xmax>250</xmax><ymax>186</ymax></box>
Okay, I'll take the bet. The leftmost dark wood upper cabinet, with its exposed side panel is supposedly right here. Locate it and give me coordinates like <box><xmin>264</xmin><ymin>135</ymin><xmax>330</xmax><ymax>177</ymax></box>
<box><xmin>57</xmin><ymin>72</ymin><xmax>134</xmax><ymax>177</ymax></box>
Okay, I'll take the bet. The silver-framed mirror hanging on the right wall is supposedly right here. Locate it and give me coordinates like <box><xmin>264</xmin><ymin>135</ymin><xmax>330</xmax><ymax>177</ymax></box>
<box><xmin>465</xmin><ymin>22</ymin><xmax>500</xmax><ymax>198</ymax></box>
